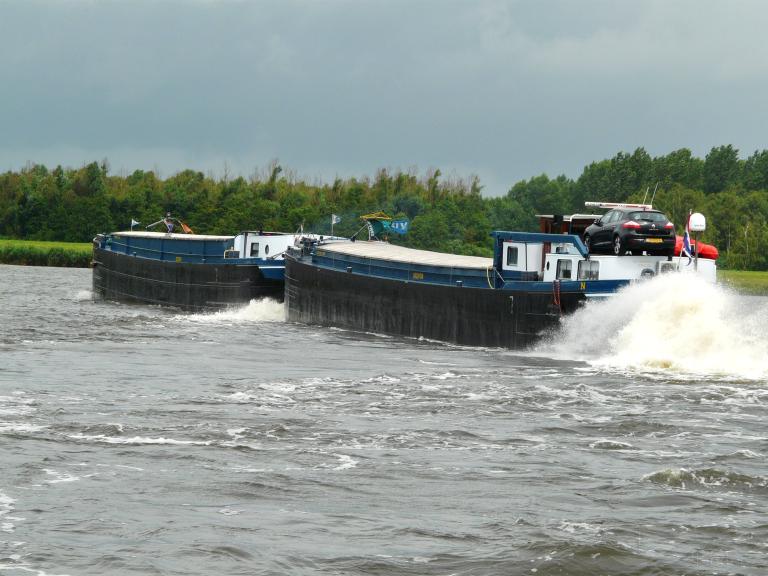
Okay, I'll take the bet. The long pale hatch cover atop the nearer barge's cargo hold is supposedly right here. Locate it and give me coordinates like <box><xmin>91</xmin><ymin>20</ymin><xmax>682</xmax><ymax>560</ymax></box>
<box><xmin>318</xmin><ymin>240</ymin><xmax>493</xmax><ymax>270</ymax></box>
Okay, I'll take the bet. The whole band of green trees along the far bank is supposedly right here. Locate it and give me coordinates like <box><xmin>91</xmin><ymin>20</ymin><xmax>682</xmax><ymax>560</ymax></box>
<box><xmin>0</xmin><ymin>145</ymin><xmax>768</xmax><ymax>270</ymax></box>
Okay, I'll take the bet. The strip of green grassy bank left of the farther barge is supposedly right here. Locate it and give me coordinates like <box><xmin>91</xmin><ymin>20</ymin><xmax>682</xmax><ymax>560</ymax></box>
<box><xmin>0</xmin><ymin>239</ymin><xmax>93</xmax><ymax>268</ymax></box>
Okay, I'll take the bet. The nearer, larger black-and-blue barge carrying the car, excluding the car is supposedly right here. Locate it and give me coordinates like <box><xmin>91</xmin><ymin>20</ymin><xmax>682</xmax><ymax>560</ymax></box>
<box><xmin>285</xmin><ymin>205</ymin><xmax>716</xmax><ymax>349</ymax></box>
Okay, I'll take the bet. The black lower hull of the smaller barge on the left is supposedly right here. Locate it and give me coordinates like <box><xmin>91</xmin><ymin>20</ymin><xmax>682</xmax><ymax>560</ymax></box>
<box><xmin>93</xmin><ymin>249</ymin><xmax>284</xmax><ymax>311</ymax></box>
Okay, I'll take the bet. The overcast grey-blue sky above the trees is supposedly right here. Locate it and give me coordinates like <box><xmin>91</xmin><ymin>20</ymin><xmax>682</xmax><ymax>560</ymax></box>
<box><xmin>0</xmin><ymin>0</ymin><xmax>768</xmax><ymax>196</ymax></box>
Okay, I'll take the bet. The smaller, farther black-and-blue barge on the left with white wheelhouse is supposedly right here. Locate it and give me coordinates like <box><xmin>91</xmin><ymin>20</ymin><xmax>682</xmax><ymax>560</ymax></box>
<box><xmin>92</xmin><ymin>231</ymin><xmax>300</xmax><ymax>311</ymax></box>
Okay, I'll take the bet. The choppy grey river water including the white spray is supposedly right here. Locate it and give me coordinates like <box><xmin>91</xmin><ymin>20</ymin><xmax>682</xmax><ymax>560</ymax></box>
<box><xmin>0</xmin><ymin>266</ymin><xmax>768</xmax><ymax>576</ymax></box>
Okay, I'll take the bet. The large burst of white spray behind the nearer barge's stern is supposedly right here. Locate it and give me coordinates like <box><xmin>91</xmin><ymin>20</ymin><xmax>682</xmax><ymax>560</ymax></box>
<box><xmin>535</xmin><ymin>274</ymin><xmax>768</xmax><ymax>379</ymax></box>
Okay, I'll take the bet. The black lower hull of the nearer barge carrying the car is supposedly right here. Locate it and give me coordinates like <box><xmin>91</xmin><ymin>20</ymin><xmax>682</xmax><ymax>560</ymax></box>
<box><xmin>285</xmin><ymin>257</ymin><xmax>585</xmax><ymax>349</ymax></box>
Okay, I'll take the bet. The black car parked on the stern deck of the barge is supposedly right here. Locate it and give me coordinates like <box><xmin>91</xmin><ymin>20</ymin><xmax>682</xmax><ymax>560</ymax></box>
<box><xmin>584</xmin><ymin>208</ymin><xmax>675</xmax><ymax>256</ymax></box>
